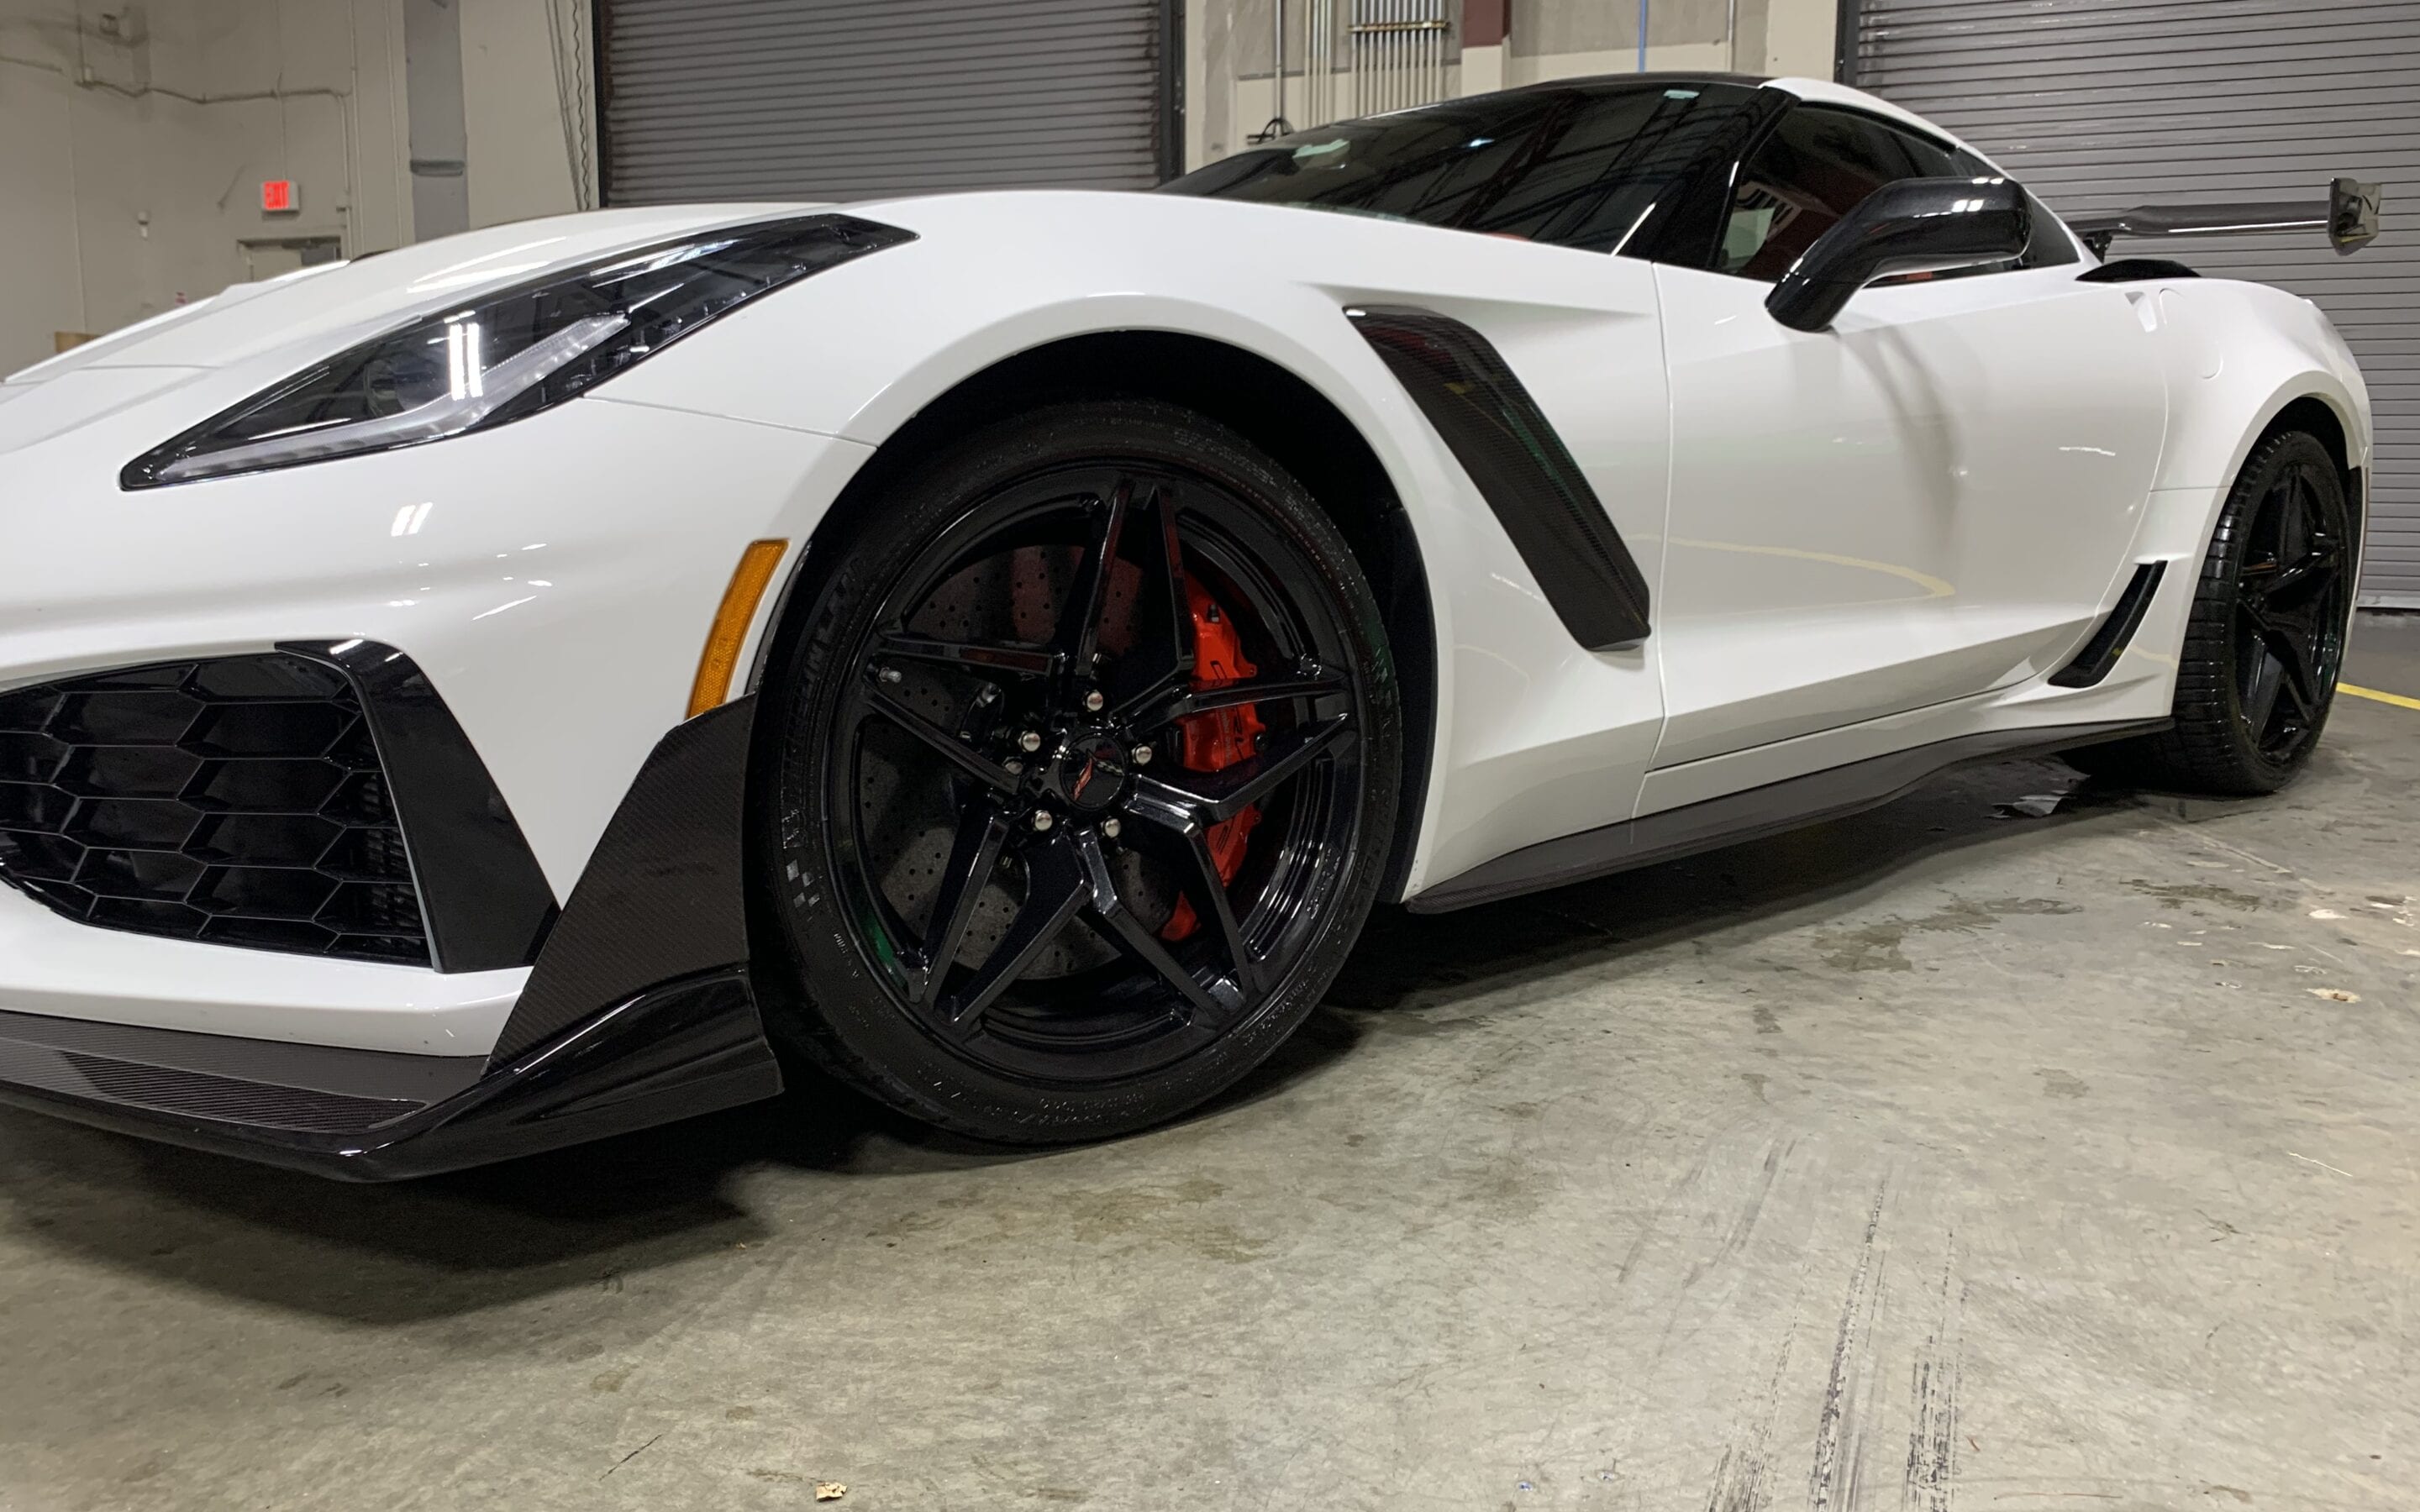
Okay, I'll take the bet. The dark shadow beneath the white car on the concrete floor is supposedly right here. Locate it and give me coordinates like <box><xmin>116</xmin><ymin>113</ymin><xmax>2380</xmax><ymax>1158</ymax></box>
<box><xmin>0</xmin><ymin>762</ymin><xmax>2275</xmax><ymax>1323</ymax></box>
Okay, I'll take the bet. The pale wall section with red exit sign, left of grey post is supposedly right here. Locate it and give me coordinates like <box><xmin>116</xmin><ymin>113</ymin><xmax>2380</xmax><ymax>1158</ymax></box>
<box><xmin>0</xmin><ymin>0</ymin><xmax>407</xmax><ymax>370</ymax></box>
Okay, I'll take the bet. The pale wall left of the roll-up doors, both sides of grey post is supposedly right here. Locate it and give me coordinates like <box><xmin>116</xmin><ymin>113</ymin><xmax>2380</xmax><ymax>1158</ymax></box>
<box><xmin>0</xmin><ymin>0</ymin><xmax>576</xmax><ymax>373</ymax></box>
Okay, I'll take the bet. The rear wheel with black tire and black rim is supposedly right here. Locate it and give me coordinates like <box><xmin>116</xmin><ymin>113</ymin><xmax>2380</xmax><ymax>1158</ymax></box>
<box><xmin>2067</xmin><ymin>431</ymin><xmax>2357</xmax><ymax>796</ymax></box>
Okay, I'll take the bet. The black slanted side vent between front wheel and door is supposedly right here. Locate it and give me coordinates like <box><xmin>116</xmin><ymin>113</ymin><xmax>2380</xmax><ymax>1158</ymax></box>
<box><xmin>1345</xmin><ymin>305</ymin><xmax>1648</xmax><ymax>651</ymax></box>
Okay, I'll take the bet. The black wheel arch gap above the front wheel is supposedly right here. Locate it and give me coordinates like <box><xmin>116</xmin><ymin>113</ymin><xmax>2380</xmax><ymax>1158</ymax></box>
<box><xmin>748</xmin><ymin>329</ymin><xmax>1440</xmax><ymax>900</ymax></box>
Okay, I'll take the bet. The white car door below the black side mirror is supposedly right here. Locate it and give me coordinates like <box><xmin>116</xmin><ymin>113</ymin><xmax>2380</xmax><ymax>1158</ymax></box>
<box><xmin>1655</xmin><ymin>269</ymin><xmax>2166</xmax><ymax>767</ymax></box>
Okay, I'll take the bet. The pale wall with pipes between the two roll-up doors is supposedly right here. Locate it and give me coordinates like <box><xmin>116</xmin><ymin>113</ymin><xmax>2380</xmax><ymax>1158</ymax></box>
<box><xmin>1186</xmin><ymin>0</ymin><xmax>1839</xmax><ymax>167</ymax></box>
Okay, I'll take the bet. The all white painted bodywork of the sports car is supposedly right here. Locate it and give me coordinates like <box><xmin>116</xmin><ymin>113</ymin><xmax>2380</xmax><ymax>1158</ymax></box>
<box><xmin>0</xmin><ymin>82</ymin><xmax>2370</xmax><ymax>1055</ymax></box>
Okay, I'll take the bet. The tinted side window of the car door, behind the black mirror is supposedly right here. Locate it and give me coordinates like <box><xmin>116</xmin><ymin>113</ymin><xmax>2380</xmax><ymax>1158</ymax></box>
<box><xmin>1713</xmin><ymin>104</ymin><xmax>2076</xmax><ymax>283</ymax></box>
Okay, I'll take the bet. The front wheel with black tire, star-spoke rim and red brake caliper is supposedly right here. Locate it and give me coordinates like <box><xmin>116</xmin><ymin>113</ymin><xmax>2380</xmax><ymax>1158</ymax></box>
<box><xmin>753</xmin><ymin>402</ymin><xmax>1403</xmax><ymax>1144</ymax></box>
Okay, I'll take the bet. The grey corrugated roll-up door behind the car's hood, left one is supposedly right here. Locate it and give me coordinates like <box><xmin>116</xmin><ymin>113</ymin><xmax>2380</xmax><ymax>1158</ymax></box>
<box><xmin>597</xmin><ymin>0</ymin><xmax>1171</xmax><ymax>206</ymax></box>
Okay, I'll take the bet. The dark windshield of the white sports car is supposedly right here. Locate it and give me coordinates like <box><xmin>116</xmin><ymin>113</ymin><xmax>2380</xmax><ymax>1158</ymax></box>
<box><xmin>1160</xmin><ymin>80</ymin><xmax>1757</xmax><ymax>252</ymax></box>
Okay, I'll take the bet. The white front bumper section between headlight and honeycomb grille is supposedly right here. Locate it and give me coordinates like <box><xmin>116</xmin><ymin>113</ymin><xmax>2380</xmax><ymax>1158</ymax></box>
<box><xmin>0</xmin><ymin>394</ymin><xmax>869</xmax><ymax>900</ymax></box>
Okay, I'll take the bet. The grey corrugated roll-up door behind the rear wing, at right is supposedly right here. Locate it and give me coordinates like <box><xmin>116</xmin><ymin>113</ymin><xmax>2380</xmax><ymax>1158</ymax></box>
<box><xmin>1854</xmin><ymin>0</ymin><xmax>2420</xmax><ymax>607</ymax></box>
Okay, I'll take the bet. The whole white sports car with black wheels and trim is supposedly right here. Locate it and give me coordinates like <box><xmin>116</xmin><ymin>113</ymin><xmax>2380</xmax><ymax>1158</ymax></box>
<box><xmin>0</xmin><ymin>75</ymin><xmax>2371</xmax><ymax>1179</ymax></box>
